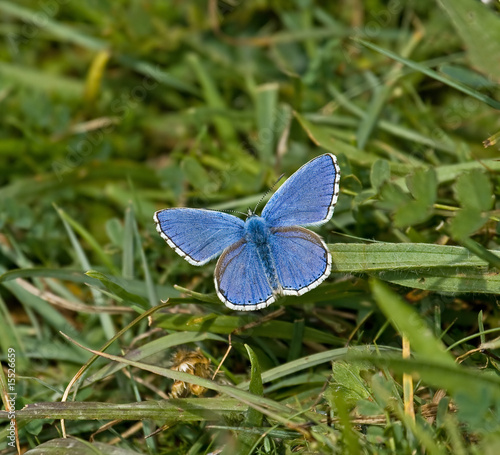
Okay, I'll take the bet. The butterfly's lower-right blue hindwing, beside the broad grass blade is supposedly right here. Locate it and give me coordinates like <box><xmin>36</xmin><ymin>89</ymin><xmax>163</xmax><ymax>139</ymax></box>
<box><xmin>269</xmin><ymin>226</ymin><xmax>332</xmax><ymax>295</ymax></box>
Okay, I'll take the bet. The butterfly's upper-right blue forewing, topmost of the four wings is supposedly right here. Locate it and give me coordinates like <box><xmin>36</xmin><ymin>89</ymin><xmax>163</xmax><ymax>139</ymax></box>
<box><xmin>262</xmin><ymin>153</ymin><xmax>340</xmax><ymax>227</ymax></box>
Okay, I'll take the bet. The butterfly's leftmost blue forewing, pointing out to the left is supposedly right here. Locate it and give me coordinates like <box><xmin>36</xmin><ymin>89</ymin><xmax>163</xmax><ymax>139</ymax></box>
<box><xmin>154</xmin><ymin>208</ymin><xmax>245</xmax><ymax>265</ymax></box>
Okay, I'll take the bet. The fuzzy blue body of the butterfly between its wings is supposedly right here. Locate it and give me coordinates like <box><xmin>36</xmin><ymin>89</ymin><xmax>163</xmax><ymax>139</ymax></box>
<box><xmin>245</xmin><ymin>216</ymin><xmax>281</xmax><ymax>293</ymax></box>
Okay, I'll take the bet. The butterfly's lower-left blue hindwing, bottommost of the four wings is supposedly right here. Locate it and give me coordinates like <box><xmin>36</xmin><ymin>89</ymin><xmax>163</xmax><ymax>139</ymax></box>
<box><xmin>214</xmin><ymin>239</ymin><xmax>276</xmax><ymax>311</ymax></box>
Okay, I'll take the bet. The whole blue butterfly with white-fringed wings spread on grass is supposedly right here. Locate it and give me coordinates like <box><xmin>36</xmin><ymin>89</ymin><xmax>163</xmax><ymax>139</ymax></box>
<box><xmin>154</xmin><ymin>153</ymin><xmax>340</xmax><ymax>311</ymax></box>
